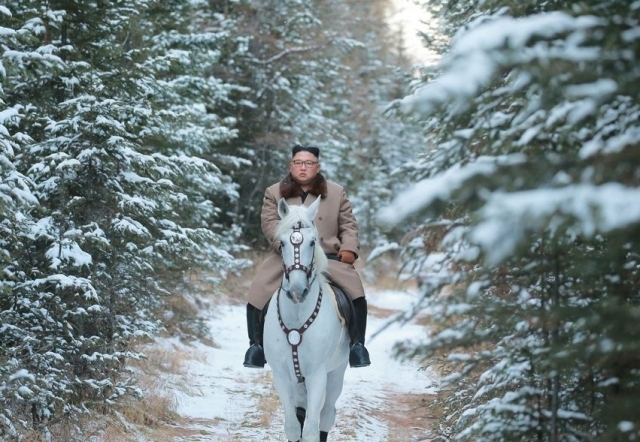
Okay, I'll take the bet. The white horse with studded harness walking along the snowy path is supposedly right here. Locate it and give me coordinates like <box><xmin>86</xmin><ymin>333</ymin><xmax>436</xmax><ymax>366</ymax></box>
<box><xmin>264</xmin><ymin>198</ymin><xmax>350</xmax><ymax>442</ymax></box>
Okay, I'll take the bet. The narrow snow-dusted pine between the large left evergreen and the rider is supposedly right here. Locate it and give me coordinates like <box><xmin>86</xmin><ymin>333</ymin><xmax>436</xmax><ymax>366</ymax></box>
<box><xmin>132</xmin><ymin>1</ymin><xmax>251</xmax><ymax>282</ymax></box>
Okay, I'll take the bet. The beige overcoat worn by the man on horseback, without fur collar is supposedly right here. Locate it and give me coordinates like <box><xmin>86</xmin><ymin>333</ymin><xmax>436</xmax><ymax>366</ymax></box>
<box><xmin>248</xmin><ymin>181</ymin><xmax>365</xmax><ymax>309</ymax></box>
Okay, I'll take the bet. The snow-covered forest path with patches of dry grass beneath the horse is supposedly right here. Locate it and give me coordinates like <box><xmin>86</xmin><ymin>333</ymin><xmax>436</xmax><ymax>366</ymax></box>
<box><xmin>155</xmin><ymin>290</ymin><xmax>437</xmax><ymax>442</ymax></box>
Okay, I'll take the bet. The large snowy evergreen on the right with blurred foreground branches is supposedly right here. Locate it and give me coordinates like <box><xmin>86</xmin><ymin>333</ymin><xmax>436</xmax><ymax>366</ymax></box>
<box><xmin>383</xmin><ymin>0</ymin><xmax>640</xmax><ymax>441</ymax></box>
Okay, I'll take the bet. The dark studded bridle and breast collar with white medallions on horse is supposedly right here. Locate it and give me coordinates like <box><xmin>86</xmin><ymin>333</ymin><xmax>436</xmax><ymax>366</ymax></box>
<box><xmin>276</xmin><ymin>222</ymin><xmax>322</xmax><ymax>383</ymax></box>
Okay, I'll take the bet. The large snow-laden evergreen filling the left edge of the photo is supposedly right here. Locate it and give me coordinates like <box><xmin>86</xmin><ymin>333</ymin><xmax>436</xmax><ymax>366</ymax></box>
<box><xmin>0</xmin><ymin>0</ymin><xmax>244</xmax><ymax>438</ymax></box>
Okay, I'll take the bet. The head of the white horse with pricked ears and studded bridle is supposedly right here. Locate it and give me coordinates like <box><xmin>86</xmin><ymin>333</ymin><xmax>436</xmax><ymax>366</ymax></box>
<box><xmin>276</xmin><ymin>198</ymin><xmax>327</xmax><ymax>303</ymax></box>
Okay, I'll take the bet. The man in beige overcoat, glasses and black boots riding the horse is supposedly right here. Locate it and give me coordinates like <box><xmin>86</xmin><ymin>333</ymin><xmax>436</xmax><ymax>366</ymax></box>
<box><xmin>244</xmin><ymin>145</ymin><xmax>371</xmax><ymax>368</ymax></box>
